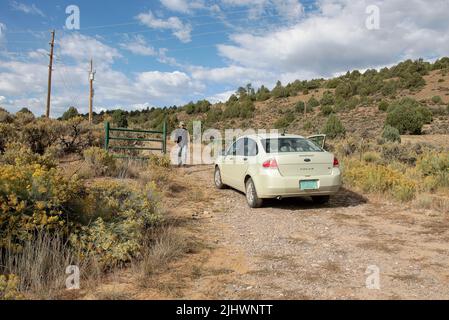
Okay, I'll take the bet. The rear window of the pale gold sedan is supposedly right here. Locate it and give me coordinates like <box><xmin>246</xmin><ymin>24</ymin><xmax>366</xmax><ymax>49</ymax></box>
<box><xmin>262</xmin><ymin>138</ymin><xmax>323</xmax><ymax>153</ymax></box>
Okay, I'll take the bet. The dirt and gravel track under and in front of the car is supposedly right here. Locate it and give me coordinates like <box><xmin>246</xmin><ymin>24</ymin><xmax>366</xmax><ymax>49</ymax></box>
<box><xmin>172</xmin><ymin>167</ymin><xmax>449</xmax><ymax>299</ymax></box>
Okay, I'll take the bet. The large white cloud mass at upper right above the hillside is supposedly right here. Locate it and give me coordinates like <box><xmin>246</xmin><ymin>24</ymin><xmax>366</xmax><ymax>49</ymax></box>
<box><xmin>218</xmin><ymin>0</ymin><xmax>449</xmax><ymax>78</ymax></box>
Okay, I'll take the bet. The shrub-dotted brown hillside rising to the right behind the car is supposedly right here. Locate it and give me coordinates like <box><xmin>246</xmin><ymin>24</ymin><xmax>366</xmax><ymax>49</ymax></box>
<box><xmin>82</xmin><ymin>57</ymin><xmax>449</xmax><ymax>144</ymax></box>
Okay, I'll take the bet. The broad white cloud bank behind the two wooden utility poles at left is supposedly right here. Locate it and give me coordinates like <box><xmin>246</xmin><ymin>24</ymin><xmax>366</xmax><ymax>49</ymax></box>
<box><xmin>0</xmin><ymin>34</ymin><xmax>205</xmax><ymax>116</ymax></box>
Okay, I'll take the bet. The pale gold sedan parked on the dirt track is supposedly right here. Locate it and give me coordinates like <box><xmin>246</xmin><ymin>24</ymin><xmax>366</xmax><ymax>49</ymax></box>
<box><xmin>214</xmin><ymin>134</ymin><xmax>341</xmax><ymax>208</ymax></box>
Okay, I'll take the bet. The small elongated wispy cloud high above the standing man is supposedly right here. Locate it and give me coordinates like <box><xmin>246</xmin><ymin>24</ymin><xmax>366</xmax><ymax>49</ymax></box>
<box><xmin>137</xmin><ymin>10</ymin><xmax>192</xmax><ymax>43</ymax></box>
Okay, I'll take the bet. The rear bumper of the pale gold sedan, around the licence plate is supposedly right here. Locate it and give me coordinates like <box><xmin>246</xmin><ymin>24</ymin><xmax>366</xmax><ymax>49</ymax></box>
<box><xmin>256</xmin><ymin>168</ymin><xmax>342</xmax><ymax>198</ymax></box>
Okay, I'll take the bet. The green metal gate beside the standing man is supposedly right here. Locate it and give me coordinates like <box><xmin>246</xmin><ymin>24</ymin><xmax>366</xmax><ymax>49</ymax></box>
<box><xmin>104</xmin><ymin>121</ymin><xmax>167</xmax><ymax>159</ymax></box>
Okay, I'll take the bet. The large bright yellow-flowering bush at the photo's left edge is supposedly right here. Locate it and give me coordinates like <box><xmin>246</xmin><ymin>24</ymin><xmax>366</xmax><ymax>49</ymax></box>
<box><xmin>0</xmin><ymin>164</ymin><xmax>82</xmax><ymax>248</ymax></box>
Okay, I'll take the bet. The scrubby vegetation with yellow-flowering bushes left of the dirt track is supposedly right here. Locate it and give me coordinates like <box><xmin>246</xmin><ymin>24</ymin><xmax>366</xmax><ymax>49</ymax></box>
<box><xmin>0</xmin><ymin>110</ymin><xmax>186</xmax><ymax>299</ymax></box>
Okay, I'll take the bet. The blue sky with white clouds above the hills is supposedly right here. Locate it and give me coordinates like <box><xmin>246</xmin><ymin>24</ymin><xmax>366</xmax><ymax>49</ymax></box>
<box><xmin>0</xmin><ymin>0</ymin><xmax>449</xmax><ymax>116</ymax></box>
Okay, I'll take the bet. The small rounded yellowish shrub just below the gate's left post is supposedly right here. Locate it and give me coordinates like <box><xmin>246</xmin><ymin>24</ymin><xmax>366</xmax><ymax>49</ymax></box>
<box><xmin>84</xmin><ymin>147</ymin><xmax>117</xmax><ymax>177</ymax></box>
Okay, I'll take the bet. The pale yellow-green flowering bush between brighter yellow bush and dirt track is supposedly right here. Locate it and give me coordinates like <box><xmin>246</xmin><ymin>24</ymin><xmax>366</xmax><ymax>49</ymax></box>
<box><xmin>70</xmin><ymin>181</ymin><xmax>161</xmax><ymax>268</ymax></box>
